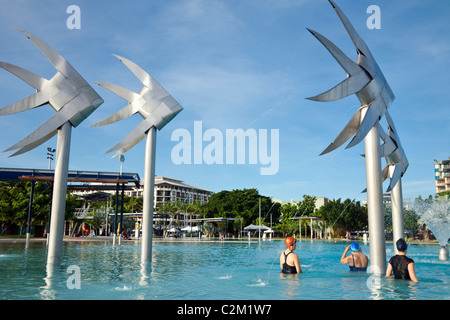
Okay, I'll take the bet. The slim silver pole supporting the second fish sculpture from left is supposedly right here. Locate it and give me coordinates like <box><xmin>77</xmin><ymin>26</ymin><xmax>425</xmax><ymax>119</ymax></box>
<box><xmin>141</xmin><ymin>126</ymin><xmax>156</xmax><ymax>265</ymax></box>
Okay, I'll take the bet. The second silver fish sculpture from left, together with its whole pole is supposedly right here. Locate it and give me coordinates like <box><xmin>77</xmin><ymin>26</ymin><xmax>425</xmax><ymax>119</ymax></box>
<box><xmin>90</xmin><ymin>55</ymin><xmax>183</xmax><ymax>264</ymax></box>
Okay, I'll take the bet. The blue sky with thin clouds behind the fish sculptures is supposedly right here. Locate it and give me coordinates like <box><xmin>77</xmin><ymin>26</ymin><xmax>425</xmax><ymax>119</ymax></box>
<box><xmin>0</xmin><ymin>0</ymin><xmax>450</xmax><ymax>201</ymax></box>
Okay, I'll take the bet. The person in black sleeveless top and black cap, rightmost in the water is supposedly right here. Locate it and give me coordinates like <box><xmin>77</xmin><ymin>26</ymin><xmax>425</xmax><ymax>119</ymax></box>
<box><xmin>386</xmin><ymin>238</ymin><xmax>419</xmax><ymax>282</ymax></box>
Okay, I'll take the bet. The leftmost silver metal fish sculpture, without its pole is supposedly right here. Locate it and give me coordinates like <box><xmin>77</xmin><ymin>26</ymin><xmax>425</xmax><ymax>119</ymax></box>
<box><xmin>0</xmin><ymin>30</ymin><xmax>103</xmax><ymax>157</ymax></box>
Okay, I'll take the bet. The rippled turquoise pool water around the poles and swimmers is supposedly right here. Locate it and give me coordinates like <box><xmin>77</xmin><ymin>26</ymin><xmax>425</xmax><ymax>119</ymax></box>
<box><xmin>0</xmin><ymin>240</ymin><xmax>450</xmax><ymax>300</ymax></box>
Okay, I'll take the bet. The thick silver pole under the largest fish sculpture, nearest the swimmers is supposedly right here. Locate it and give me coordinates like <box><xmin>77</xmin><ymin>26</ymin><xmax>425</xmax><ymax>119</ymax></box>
<box><xmin>362</xmin><ymin>109</ymin><xmax>386</xmax><ymax>274</ymax></box>
